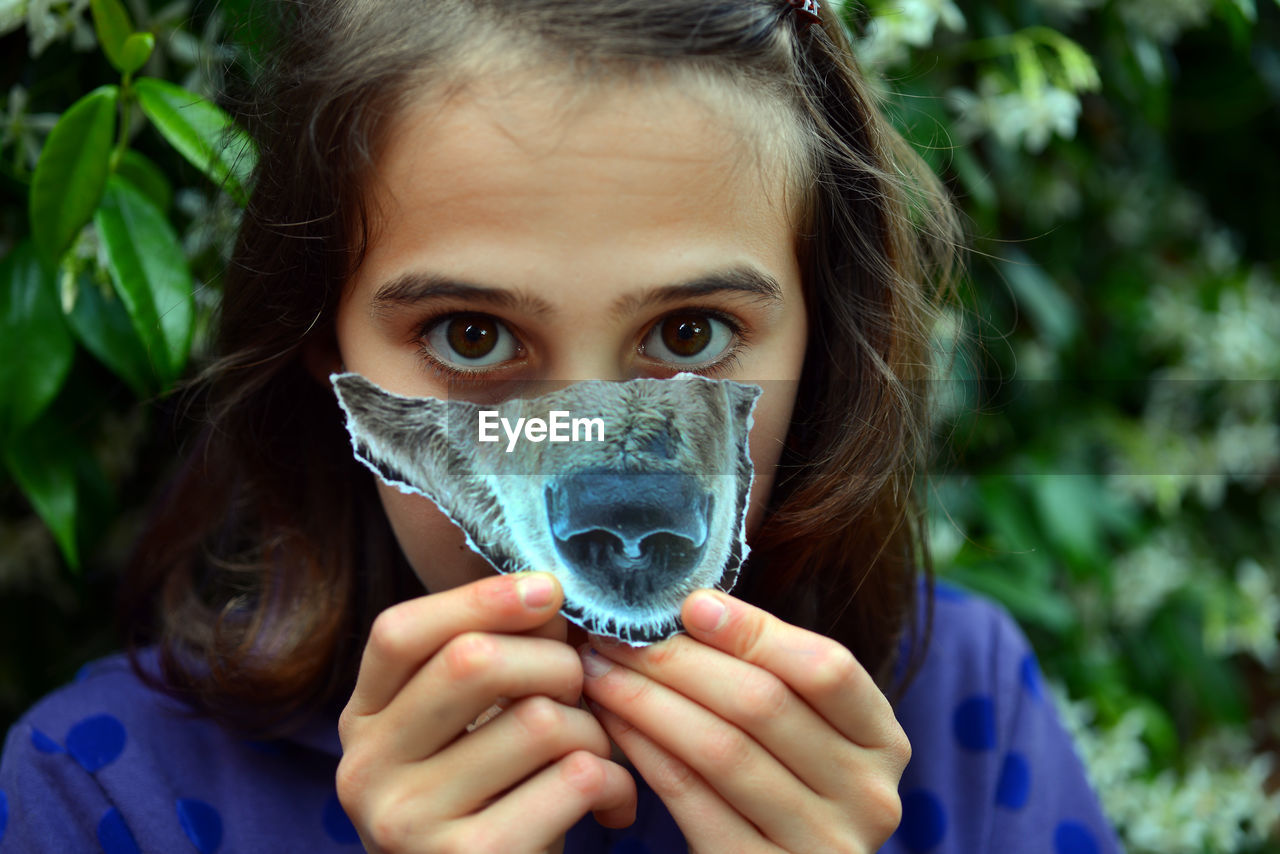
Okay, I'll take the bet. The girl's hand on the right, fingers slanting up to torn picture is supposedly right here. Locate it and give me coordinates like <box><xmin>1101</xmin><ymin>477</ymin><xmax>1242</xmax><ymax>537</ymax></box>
<box><xmin>582</xmin><ymin>590</ymin><xmax>911</xmax><ymax>854</ymax></box>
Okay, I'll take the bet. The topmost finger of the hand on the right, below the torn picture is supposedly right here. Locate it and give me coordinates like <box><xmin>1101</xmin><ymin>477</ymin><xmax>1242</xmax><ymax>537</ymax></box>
<box><xmin>681</xmin><ymin>590</ymin><xmax>905</xmax><ymax>748</ymax></box>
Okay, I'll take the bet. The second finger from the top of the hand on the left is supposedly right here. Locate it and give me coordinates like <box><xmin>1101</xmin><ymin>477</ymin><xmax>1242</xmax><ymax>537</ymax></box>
<box><xmin>376</xmin><ymin>631</ymin><xmax>582</xmax><ymax>762</ymax></box>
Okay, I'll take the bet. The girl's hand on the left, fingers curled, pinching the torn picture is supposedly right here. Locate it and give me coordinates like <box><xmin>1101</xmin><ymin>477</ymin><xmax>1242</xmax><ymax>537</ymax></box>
<box><xmin>337</xmin><ymin>572</ymin><xmax>635</xmax><ymax>854</ymax></box>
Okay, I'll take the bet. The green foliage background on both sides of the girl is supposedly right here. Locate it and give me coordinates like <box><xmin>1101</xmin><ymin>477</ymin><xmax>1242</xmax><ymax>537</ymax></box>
<box><xmin>0</xmin><ymin>0</ymin><xmax>1280</xmax><ymax>854</ymax></box>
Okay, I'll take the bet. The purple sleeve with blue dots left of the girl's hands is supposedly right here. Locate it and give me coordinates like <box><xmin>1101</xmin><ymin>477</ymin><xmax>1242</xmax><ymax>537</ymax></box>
<box><xmin>0</xmin><ymin>653</ymin><xmax>360</xmax><ymax>854</ymax></box>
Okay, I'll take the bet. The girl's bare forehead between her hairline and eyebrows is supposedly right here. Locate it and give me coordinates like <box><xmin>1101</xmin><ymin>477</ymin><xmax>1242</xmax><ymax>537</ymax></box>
<box><xmin>356</xmin><ymin>71</ymin><xmax>796</xmax><ymax>300</ymax></box>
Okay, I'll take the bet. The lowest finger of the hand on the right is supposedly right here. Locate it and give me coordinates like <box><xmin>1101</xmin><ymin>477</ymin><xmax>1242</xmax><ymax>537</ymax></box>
<box><xmin>589</xmin><ymin>703</ymin><xmax>772</xmax><ymax>851</ymax></box>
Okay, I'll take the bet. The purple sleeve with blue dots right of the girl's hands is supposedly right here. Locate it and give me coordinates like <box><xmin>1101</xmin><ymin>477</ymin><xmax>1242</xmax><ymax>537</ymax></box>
<box><xmin>881</xmin><ymin>588</ymin><xmax>1121</xmax><ymax>854</ymax></box>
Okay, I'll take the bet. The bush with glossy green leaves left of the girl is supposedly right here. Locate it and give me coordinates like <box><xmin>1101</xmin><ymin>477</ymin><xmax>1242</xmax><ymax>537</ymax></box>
<box><xmin>0</xmin><ymin>0</ymin><xmax>253</xmax><ymax>726</ymax></box>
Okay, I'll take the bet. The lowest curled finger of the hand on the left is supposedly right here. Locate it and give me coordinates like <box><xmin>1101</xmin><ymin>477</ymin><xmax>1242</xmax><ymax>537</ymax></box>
<box><xmin>456</xmin><ymin>750</ymin><xmax>636</xmax><ymax>851</ymax></box>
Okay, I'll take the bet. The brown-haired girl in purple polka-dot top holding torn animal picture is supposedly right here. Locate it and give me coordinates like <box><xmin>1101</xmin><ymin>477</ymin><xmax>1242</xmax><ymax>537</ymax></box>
<box><xmin>0</xmin><ymin>0</ymin><xmax>1114</xmax><ymax>854</ymax></box>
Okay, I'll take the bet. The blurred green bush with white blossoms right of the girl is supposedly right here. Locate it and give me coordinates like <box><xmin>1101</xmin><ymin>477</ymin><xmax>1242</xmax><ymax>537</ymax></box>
<box><xmin>842</xmin><ymin>0</ymin><xmax>1280</xmax><ymax>854</ymax></box>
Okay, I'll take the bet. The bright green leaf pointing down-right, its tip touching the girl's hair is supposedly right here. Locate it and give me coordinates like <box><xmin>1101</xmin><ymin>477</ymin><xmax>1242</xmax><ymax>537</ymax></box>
<box><xmin>134</xmin><ymin>77</ymin><xmax>255</xmax><ymax>205</ymax></box>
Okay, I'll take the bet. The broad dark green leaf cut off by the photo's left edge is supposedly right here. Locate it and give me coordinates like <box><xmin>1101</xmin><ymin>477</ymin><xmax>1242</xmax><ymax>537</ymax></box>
<box><xmin>0</xmin><ymin>242</ymin><xmax>76</xmax><ymax>438</ymax></box>
